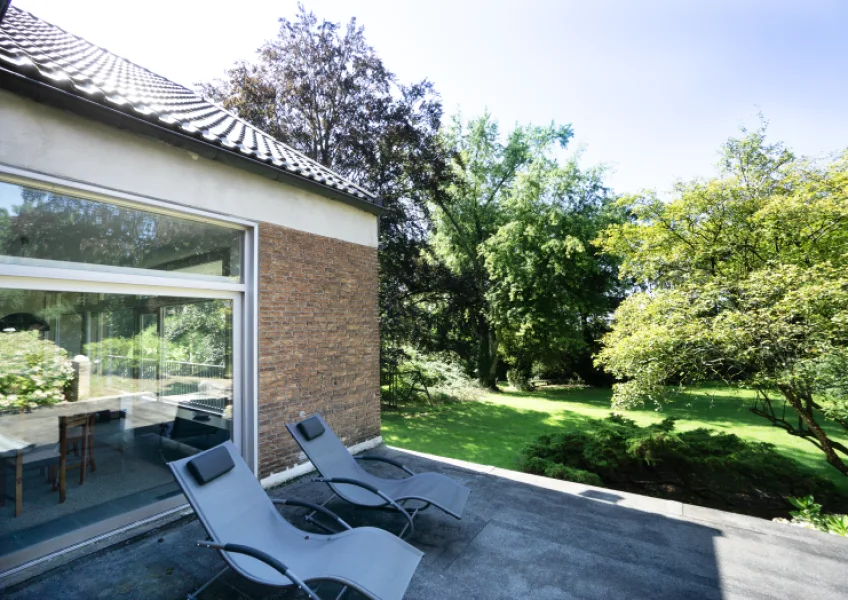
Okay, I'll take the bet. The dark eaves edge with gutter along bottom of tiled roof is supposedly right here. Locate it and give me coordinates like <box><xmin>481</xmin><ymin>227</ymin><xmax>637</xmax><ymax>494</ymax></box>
<box><xmin>0</xmin><ymin>65</ymin><xmax>386</xmax><ymax>216</ymax></box>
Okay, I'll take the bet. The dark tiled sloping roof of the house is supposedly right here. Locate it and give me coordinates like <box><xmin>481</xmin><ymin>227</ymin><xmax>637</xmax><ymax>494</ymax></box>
<box><xmin>0</xmin><ymin>6</ymin><xmax>381</xmax><ymax>213</ymax></box>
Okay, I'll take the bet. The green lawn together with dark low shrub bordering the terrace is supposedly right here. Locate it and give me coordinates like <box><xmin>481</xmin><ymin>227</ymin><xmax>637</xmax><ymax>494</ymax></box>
<box><xmin>383</xmin><ymin>384</ymin><xmax>848</xmax><ymax>518</ymax></box>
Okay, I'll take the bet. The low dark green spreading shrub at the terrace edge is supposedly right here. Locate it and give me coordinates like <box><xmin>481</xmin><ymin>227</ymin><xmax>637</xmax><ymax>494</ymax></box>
<box><xmin>521</xmin><ymin>415</ymin><xmax>845</xmax><ymax>515</ymax></box>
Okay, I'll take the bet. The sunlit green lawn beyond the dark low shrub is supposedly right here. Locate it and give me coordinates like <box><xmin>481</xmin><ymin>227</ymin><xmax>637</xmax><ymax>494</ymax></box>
<box><xmin>383</xmin><ymin>387</ymin><xmax>848</xmax><ymax>493</ymax></box>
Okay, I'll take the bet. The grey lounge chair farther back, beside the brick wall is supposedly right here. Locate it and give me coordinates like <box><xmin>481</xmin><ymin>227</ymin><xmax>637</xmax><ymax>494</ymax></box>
<box><xmin>286</xmin><ymin>414</ymin><xmax>471</xmax><ymax>538</ymax></box>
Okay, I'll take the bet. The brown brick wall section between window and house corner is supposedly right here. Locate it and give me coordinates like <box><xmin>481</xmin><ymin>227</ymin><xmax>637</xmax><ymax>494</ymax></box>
<box><xmin>259</xmin><ymin>223</ymin><xmax>380</xmax><ymax>477</ymax></box>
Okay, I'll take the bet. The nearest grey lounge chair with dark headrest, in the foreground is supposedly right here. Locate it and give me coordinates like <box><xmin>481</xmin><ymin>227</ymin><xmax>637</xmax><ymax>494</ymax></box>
<box><xmin>168</xmin><ymin>442</ymin><xmax>423</xmax><ymax>600</ymax></box>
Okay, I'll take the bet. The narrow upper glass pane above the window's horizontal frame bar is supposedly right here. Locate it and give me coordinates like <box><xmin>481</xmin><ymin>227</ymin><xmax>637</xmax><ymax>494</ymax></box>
<box><xmin>0</xmin><ymin>182</ymin><xmax>244</xmax><ymax>280</ymax></box>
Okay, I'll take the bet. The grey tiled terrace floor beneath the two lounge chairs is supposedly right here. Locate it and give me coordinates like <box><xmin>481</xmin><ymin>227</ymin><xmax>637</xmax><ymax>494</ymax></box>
<box><xmin>3</xmin><ymin>447</ymin><xmax>848</xmax><ymax>600</ymax></box>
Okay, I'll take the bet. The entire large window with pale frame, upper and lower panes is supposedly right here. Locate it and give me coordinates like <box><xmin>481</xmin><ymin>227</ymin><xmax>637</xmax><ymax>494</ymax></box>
<box><xmin>0</xmin><ymin>176</ymin><xmax>252</xmax><ymax>573</ymax></box>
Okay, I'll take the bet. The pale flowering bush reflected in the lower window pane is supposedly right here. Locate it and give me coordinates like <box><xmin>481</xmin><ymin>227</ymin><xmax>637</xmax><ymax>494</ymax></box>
<box><xmin>0</xmin><ymin>331</ymin><xmax>74</xmax><ymax>410</ymax></box>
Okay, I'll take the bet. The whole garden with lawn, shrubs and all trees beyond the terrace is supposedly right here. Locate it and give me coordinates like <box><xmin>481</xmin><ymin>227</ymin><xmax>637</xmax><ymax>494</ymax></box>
<box><xmin>202</xmin><ymin>7</ymin><xmax>848</xmax><ymax>529</ymax></box>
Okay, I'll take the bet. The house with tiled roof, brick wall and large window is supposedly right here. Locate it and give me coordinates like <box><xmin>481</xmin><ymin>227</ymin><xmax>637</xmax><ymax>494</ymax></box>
<box><xmin>0</xmin><ymin>0</ymin><xmax>382</xmax><ymax>581</ymax></box>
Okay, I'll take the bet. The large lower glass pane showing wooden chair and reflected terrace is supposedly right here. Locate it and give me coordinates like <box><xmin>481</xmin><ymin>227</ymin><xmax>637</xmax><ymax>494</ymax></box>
<box><xmin>0</xmin><ymin>290</ymin><xmax>233</xmax><ymax>561</ymax></box>
